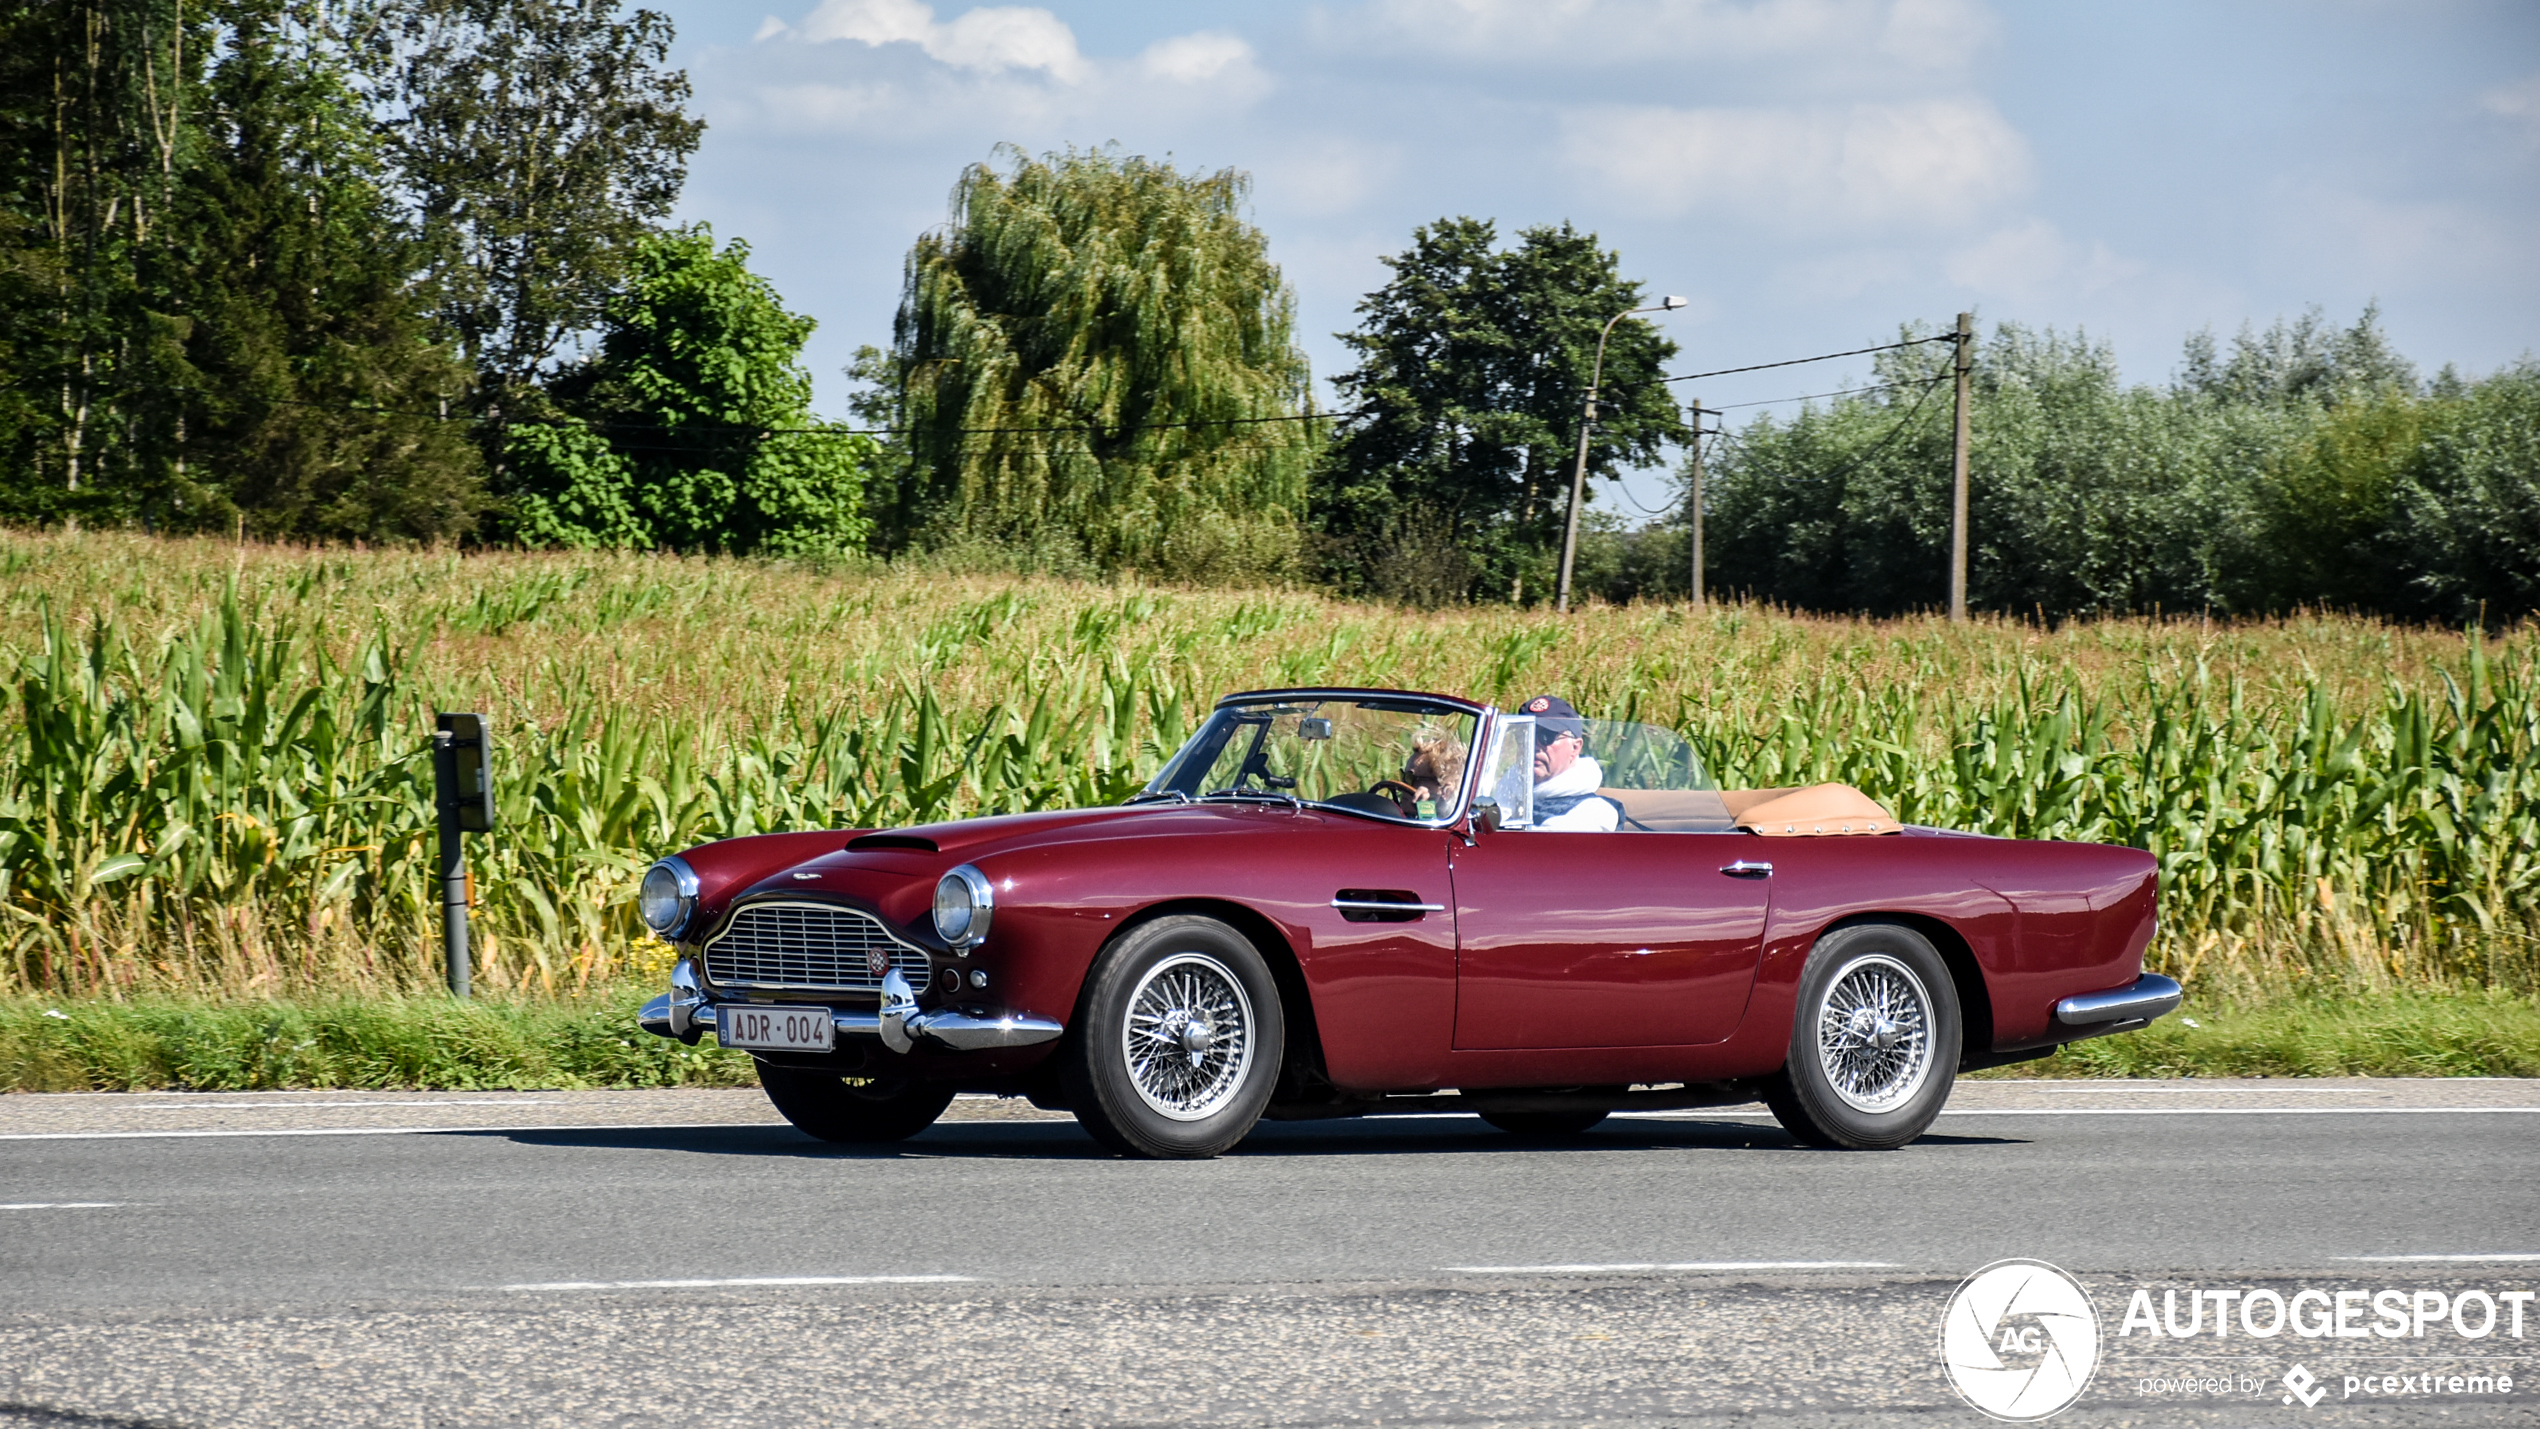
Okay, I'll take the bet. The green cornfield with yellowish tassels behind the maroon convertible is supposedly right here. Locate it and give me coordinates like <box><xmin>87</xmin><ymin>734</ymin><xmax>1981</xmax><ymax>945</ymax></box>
<box><xmin>0</xmin><ymin>525</ymin><xmax>2540</xmax><ymax>998</ymax></box>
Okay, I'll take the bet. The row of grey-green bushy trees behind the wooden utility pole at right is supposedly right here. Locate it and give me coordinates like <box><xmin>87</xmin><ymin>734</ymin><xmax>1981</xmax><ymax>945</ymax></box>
<box><xmin>1686</xmin><ymin>312</ymin><xmax>2540</xmax><ymax>622</ymax></box>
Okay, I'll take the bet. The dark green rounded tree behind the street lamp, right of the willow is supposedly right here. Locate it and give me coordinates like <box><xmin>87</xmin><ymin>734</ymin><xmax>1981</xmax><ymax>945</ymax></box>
<box><xmin>1313</xmin><ymin>218</ymin><xmax>1687</xmax><ymax>599</ymax></box>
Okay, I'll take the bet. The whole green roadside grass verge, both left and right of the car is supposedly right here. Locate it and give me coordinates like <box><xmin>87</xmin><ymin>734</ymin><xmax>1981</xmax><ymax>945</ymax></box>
<box><xmin>0</xmin><ymin>990</ymin><xmax>2540</xmax><ymax>1091</ymax></box>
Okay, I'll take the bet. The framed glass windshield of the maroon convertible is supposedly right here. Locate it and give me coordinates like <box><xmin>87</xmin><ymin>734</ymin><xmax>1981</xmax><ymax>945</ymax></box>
<box><xmin>1138</xmin><ymin>698</ymin><xmax>1478</xmax><ymax>820</ymax></box>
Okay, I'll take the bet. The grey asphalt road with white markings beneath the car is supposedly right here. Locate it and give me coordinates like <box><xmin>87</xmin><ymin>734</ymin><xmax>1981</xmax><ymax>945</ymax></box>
<box><xmin>0</xmin><ymin>1084</ymin><xmax>2540</xmax><ymax>1426</ymax></box>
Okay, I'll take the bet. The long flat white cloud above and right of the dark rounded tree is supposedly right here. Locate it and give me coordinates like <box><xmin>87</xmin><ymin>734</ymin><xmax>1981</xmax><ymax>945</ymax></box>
<box><xmin>1565</xmin><ymin>99</ymin><xmax>2029</xmax><ymax>228</ymax></box>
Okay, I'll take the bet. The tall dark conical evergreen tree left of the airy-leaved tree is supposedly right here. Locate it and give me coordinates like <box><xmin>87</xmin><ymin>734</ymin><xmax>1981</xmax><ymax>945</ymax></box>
<box><xmin>144</xmin><ymin>0</ymin><xmax>483</xmax><ymax>541</ymax></box>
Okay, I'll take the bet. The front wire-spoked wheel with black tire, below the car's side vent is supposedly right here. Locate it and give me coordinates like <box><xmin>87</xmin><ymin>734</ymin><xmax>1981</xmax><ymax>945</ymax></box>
<box><xmin>1062</xmin><ymin>916</ymin><xmax>1288</xmax><ymax>1160</ymax></box>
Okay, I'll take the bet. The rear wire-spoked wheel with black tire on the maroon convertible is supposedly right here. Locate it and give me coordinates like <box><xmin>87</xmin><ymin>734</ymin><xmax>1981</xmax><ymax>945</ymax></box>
<box><xmin>1763</xmin><ymin>924</ymin><xmax>1966</xmax><ymax>1150</ymax></box>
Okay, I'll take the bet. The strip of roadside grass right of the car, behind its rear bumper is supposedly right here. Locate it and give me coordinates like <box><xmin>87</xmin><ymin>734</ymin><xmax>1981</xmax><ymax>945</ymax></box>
<box><xmin>1976</xmin><ymin>990</ymin><xmax>2540</xmax><ymax>1079</ymax></box>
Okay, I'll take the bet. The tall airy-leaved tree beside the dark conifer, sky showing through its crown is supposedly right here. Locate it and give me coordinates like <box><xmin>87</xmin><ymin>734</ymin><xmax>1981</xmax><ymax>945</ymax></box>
<box><xmin>361</xmin><ymin>0</ymin><xmax>706</xmax><ymax>426</ymax></box>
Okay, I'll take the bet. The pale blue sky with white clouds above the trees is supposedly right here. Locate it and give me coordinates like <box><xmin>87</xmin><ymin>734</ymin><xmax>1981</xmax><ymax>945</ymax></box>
<box><xmin>645</xmin><ymin>0</ymin><xmax>2540</xmax><ymax>513</ymax></box>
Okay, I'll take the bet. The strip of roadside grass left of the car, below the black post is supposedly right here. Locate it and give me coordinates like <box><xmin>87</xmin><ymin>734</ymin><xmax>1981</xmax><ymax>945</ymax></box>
<box><xmin>0</xmin><ymin>990</ymin><xmax>757</xmax><ymax>1091</ymax></box>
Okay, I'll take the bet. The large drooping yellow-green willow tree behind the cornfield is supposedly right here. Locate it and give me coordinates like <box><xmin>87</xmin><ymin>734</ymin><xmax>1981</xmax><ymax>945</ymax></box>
<box><xmin>859</xmin><ymin>147</ymin><xmax>1318</xmax><ymax>579</ymax></box>
